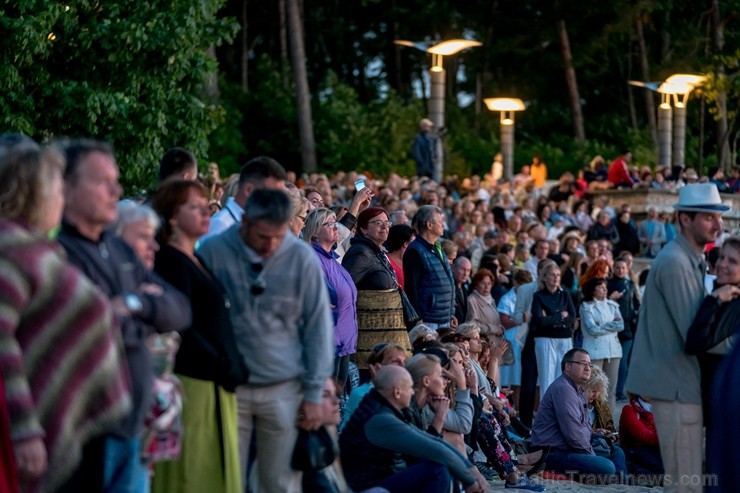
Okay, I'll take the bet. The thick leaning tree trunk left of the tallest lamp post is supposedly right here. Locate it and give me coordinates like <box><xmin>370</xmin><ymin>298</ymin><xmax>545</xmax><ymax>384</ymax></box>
<box><xmin>286</xmin><ymin>0</ymin><xmax>317</xmax><ymax>173</ymax></box>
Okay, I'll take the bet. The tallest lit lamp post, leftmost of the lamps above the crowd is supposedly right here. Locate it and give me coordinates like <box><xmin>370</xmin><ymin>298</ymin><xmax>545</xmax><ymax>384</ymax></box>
<box><xmin>394</xmin><ymin>39</ymin><xmax>481</xmax><ymax>183</ymax></box>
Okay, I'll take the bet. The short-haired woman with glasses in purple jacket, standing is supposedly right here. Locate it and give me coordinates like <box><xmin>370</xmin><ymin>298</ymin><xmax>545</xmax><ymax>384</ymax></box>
<box><xmin>303</xmin><ymin>207</ymin><xmax>357</xmax><ymax>388</ymax></box>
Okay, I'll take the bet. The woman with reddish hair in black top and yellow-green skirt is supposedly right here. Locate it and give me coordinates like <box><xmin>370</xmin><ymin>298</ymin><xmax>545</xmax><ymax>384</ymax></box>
<box><xmin>152</xmin><ymin>180</ymin><xmax>246</xmax><ymax>493</ymax></box>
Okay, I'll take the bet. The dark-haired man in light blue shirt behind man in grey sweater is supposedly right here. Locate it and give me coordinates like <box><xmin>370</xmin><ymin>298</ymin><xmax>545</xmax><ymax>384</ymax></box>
<box><xmin>201</xmin><ymin>156</ymin><xmax>287</xmax><ymax>242</ymax></box>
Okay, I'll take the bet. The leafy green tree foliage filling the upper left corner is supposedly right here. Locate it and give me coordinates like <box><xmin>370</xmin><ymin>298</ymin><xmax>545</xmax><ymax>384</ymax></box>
<box><xmin>0</xmin><ymin>0</ymin><xmax>238</xmax><ymax>193</ymax></box>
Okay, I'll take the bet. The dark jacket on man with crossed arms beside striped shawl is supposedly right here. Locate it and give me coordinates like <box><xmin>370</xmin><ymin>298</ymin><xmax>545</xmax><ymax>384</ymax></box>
<box><xmin>57</xmin><ymin>221</ymin><xmax>191</xmax><ymax>438</ymax></box>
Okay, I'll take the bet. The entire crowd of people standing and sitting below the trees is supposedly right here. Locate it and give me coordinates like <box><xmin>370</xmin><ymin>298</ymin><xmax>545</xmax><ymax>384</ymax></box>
<box><xmin>0</xmin><ymin>133</ymin><xmax>740</xmax><ymax>493</ymax></box>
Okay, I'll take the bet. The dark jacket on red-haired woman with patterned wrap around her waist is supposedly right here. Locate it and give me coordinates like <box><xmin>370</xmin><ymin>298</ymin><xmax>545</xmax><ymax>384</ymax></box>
<box><xmin>342</xmin><ymin>234</ymin><xmax>398</xmax><ymax>291</ymax></box>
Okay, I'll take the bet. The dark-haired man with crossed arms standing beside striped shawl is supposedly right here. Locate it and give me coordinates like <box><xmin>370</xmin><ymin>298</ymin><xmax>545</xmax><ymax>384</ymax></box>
<box><xmin>58</xmin><ymin>140</ymin><xmax>191</xmax><ymax>493</ymax></box>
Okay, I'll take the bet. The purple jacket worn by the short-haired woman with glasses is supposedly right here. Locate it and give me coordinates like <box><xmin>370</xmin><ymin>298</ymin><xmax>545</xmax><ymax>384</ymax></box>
<box><xmin>311</xmin><ymin>243</ymin><xmax>357</xmax><ymax>356</ymax></box>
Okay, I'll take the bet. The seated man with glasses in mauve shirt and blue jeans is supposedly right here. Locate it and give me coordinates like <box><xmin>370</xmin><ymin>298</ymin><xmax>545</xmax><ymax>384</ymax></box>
<box><xmin>532</xmin><ymin>348</ymin><xmax>627</xmax><ymax>480</ymax></box>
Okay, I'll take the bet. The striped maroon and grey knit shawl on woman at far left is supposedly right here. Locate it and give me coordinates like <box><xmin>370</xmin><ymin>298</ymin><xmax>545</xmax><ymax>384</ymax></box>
<box><xmin>0</xmin><ymin>219</ymin><xmax>131</xmax><ymax>492</ymax></box>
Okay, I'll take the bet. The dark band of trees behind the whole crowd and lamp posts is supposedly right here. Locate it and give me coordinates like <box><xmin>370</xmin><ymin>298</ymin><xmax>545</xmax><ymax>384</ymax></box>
<box><xmin>0</xmin><ymin>0</ymin><xmax>740</xmax><ymax>191</ymax></box>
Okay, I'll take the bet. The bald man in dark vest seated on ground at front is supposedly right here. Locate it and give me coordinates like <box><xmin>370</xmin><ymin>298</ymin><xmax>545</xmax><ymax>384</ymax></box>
<box><xmin>339</xmin><ymin>365</ymin><xmax>489</xmax><ymax>493</ymax></box>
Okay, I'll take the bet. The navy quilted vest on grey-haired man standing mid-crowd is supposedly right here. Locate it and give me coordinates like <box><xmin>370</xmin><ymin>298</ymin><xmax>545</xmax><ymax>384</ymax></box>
<box><xmin>403</xmin><ymin>236</ymin><xmax>455</xmax><ymax>325</ymax></box>
